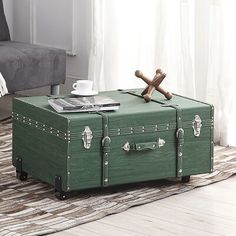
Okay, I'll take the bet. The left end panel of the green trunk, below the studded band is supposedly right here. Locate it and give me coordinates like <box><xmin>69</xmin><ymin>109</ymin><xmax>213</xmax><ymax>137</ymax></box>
<box><xmin>13</xmin><ymin>122</ymin><xmax>67</xmax><ymax>188</ymax></box>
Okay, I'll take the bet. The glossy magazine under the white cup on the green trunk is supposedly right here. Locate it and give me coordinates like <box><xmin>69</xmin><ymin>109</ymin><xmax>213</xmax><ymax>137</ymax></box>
<box><xmin>48</xmin><ymin>95</ymin><xmax>120</xmax><ymax>113</ymax></box>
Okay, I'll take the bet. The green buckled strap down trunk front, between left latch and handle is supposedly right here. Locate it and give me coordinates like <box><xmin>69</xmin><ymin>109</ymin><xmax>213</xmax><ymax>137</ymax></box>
<box><xmin>97</xmin><ymin>112</ymin><xmax>111</xmax><ymax>187</ymax></box>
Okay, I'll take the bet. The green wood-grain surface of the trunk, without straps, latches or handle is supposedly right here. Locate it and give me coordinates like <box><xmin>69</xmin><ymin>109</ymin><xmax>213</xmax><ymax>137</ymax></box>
<box><xmin>13</xmin><ymin>90</ymin><xmax>213</xmax><ymax>191</ymax></box>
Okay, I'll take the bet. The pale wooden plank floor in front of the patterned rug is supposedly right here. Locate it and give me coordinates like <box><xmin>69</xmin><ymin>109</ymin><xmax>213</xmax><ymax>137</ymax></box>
<box><xmin>51</xmin><ymin>176</ymin><xmax>236</xmax><ymax>236</ymax></box>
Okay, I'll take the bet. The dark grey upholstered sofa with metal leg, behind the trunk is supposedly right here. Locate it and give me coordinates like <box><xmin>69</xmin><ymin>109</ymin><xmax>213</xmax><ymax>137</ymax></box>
<box><xmin>0</xmin><ymin>0</ymin><xmax>66</xmax><ymax>94</ymax></box>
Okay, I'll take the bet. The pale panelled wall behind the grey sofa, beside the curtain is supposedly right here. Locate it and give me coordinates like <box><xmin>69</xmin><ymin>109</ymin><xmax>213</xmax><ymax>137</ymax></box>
<box><xmin>11</xmin><ymin>0</ymin><xmax>91</xmax><ymax>94</ymax></box>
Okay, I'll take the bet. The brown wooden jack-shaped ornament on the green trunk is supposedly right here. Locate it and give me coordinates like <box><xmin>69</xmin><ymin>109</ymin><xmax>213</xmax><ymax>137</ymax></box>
<box><xmin>135</xmin><ymin>69</ymin><xmax>172</xmax><ymax>102</ymax></box>
